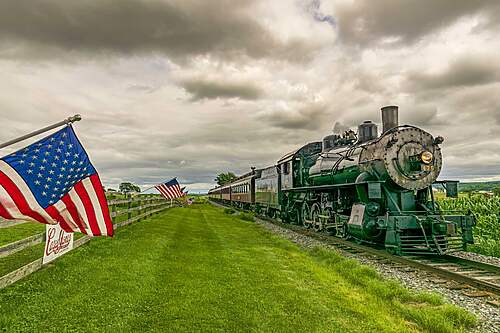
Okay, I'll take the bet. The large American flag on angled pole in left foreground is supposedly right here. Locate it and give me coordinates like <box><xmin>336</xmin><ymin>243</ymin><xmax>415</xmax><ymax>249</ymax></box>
<box><xmin>0</xmin><ymin>126</ymin><xmax>113</xmax><ymax>236</ymax></box>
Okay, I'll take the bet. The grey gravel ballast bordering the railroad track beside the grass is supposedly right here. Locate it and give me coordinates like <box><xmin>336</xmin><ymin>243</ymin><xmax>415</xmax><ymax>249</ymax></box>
<box><xmin>256</xmin><ymin>219</ymin><xmax>500</xmax><ymax>333</ymax></box>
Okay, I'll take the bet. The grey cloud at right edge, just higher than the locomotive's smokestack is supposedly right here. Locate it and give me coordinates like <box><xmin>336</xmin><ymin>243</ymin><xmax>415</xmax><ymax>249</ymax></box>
<box><xmin>407</xmin><ymin>55</ymin><xmax>500</xmax><ymax>90</ymax></box>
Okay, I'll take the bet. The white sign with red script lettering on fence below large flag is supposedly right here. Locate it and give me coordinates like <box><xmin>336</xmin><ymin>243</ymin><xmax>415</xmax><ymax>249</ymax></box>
<box><xmin>43</xmin><ymin>224</ymin><xmax>73</xmax><ymax>264</ymax></box>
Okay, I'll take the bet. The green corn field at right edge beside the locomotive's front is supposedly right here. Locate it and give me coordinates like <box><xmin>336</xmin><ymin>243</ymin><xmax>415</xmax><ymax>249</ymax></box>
<box><xmin>438</xmin><ymin>194</ymin><xmax>500</xmax><ymax>257</ymax></box>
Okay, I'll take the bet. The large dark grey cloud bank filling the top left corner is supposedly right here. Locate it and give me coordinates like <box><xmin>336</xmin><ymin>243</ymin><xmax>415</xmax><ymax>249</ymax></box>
<box><xmin>0</xmin><ymin>0</ymin><xmax>305</xmax><ymax>60</ymax></box>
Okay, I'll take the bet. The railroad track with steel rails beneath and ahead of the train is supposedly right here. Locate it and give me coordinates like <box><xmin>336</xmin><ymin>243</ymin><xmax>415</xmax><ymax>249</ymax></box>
<box><xmin>212</xmin><ymin>202</ymin><xmax>500</xmax><ymax>307</ymax></box>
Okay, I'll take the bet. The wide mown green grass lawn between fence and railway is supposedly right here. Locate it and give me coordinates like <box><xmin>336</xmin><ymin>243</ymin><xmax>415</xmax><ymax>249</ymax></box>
<box><xmin>0</xmin><ymin>205</ymin><xmax>475</xmax><ymax>332</ymax></box>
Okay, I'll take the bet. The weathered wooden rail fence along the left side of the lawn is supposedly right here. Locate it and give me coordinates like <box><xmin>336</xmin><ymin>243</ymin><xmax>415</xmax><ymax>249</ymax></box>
<box><xmin>0</xmin><ymin>196</ymin><xmax>170</xmax><ymax>289</ymax></box>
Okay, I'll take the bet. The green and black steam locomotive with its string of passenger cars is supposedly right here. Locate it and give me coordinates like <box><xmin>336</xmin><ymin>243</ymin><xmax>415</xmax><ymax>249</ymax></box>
<box><xmin>209</xmin><ymin>106</ymin><xmax>475</xmax><ymax>255</ymax></box>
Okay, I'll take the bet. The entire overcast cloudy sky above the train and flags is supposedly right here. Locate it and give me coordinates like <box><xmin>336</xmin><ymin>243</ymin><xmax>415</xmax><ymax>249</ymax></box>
<box><xmin>0</xmin><ymin>0</ymin><xmax>500</xmax><ymax>191</ymax></box>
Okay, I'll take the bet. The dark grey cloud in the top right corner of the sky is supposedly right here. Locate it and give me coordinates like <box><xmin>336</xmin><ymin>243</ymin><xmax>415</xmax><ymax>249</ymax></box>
<box><xmin>335</xmin><ymin>0</ymin><xmax>500</xmax><ymax>45</ymax></box>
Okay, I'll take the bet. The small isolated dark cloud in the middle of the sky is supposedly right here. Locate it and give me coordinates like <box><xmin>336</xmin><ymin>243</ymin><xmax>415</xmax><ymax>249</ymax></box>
<box><xmin>180</xmin><ymin>79</ymin><xmax>263</xmax><ymax>101</ymax></box>
